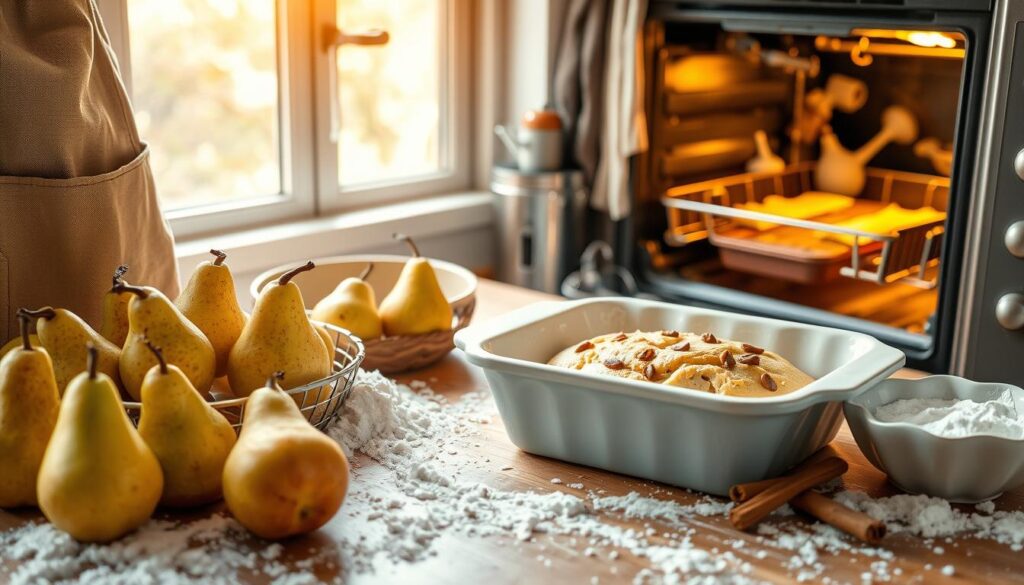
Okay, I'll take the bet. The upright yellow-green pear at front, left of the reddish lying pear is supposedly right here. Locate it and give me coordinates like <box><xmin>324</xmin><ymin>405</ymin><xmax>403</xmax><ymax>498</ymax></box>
<box><xmin>37</xmin><ymin>347</ymin><xmax>164</xmax><ymax>542</ymax></box>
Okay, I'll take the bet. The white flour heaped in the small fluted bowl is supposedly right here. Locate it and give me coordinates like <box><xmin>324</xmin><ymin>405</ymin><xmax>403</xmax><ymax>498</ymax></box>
<box><xmin>873</xmin><ymin>389</ymin><xmax>1024</xmax><ymax>440</ymax></box>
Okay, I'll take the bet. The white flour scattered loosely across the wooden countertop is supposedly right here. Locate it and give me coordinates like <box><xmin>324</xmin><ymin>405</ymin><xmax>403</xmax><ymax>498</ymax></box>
<box><xmin>6</xmin><ymin>372</ymin><xmax>1024</xmax><ymax>585</ymax></box>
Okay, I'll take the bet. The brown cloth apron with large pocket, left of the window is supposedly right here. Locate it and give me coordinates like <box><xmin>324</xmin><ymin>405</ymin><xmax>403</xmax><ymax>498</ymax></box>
<box><xmin>0</xmin><ymin>0</ymin><xmax>178</xmax><ymax>343</ymax></box>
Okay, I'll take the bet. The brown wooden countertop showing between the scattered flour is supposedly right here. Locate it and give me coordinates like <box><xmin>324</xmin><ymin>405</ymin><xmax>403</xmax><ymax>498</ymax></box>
<box><xmin>0</xmin><ymin>281</ymin><xmax>1024</xmax><ymax>585</ymax></box>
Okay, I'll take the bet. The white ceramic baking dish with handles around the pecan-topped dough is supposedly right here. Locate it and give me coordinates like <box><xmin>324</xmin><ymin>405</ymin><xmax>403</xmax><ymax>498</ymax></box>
<box><xmin>455</xmin><ymin>298</ymin><xmax>905</xmax><ymax>495</ymax></box>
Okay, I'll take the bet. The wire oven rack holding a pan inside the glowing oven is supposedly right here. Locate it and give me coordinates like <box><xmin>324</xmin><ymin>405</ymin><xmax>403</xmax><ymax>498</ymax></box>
<box><xmin>662</xmin><ymin>161</ymin><xmax>949</xmax><ymax>289</ymax></box>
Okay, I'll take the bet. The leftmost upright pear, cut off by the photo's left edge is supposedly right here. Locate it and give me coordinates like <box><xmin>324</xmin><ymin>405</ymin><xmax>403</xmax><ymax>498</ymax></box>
<box><xmin>0</xmin><ymin>316</ymin><xmax>60</xmax><ymax>508</ymax></box>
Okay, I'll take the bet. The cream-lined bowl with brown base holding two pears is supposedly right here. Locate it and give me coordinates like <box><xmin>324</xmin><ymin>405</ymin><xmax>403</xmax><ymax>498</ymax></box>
<box><xmin>249</xmin><ymin>254</ymin><xmax>476</xmax><ymax>375</ymax></box>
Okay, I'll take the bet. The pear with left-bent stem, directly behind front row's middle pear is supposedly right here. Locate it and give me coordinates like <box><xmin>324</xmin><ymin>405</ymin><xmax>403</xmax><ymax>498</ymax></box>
<box><xmin>115</xmin><ymin>284</ymin><xmax>217</xmax><ymax>401</ymax></box>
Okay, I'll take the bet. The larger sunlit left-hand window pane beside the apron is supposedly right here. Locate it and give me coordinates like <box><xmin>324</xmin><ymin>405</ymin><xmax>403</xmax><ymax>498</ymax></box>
<box><xmin>128</xmin><ymin>0</ymin><xmax>282</xmax><ymax>210</ymax></box>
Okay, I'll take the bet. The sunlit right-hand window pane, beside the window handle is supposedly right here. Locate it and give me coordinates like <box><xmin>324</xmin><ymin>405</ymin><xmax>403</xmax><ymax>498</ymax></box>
<box><xmin>338</xmin><ymin>0</ymin><xmax>444</xmax><ymax>189</ymax></box>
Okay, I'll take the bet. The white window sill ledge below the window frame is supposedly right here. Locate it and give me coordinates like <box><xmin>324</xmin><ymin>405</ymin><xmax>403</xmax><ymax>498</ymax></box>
<box><xmin>176</xmin><ymin>192</ymin><xmax>494</xmax><ymax>278</ymax></box>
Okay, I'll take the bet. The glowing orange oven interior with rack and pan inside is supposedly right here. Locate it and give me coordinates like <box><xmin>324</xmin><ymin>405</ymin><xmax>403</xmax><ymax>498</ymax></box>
<box><xmin>638</xmin><ymin>23</ymin><xmax>967</xmax><ymax>350</ymax></box>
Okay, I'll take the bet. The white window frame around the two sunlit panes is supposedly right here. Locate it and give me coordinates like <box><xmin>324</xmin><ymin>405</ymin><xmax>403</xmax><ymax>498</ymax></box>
<box><xmin>95</xmin><ymin>0</ymin><xmax>473</xmax><ymax>239</ymax></box>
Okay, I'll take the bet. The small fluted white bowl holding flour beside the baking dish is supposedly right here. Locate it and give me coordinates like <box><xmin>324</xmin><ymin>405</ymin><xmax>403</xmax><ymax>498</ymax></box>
<box><xmin>843</xmin><ymin>376</ymin><xmax>1024</xmax><ymax>504</ymax></box>
